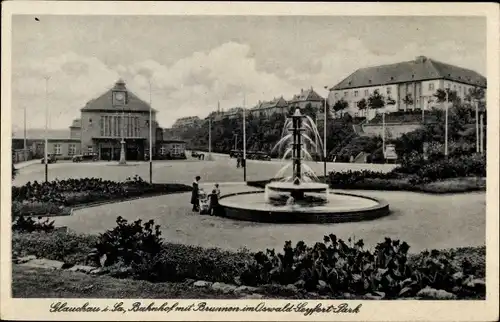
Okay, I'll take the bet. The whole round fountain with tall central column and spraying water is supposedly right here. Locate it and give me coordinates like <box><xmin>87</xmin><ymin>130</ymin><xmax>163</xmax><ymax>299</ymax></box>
<box><xmin>219</xmin><ymin>108</ymin><xmax>389</xmax><ymax>223</ymax></box>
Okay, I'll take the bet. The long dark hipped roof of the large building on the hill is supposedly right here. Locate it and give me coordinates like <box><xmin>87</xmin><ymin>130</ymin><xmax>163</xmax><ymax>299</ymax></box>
<box><xmin>330</xmin><ymin>56</ymin><xmax>486</xmax><ymax>90</ymax></box>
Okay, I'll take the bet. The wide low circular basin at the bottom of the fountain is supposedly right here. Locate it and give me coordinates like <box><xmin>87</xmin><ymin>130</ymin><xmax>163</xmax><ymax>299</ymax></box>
<box><xmin>219</xmin><ymin>191</ymin><xmax>389</xmax><ymax>223</ymax></box>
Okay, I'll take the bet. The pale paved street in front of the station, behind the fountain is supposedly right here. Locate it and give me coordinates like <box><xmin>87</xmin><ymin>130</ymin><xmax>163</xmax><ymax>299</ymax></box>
<box><xmin>14</xmin><ymin>154</ymin><xmax>394</xmax><ymax>186</ymax></box>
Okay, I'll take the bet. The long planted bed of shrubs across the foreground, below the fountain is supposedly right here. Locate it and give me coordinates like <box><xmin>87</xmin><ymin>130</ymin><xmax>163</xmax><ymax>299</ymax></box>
<box><xmin>12</xmin><ymin>218</ymin><xmax>485</xmax><ymax>299</ymax></box>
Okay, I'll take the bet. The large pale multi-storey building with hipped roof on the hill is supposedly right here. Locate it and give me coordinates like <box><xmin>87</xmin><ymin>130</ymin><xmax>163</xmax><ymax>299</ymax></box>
<box><xmin>328</xmin><ymin>56</ymin><xmax>486</xmax><ymax>119</ymax></box>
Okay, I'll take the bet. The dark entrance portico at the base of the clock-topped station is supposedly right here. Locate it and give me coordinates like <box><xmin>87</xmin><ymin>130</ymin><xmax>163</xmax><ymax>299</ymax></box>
<box><xmin>94</xmin><ymin>139</ymin><xmax>147</xmax><ymax>161</ymax></box>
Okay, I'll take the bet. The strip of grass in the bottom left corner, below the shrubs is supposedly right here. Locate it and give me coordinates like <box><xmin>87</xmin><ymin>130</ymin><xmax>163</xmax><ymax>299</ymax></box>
<box><xmin>12</xmin><ymin>265</ymin><xmax>238</xmax><ymax>299</ymax></box>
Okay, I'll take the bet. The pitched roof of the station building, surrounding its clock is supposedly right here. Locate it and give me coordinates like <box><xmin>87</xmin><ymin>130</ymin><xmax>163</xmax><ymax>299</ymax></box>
<box><xmin>81</xmin><ymin>79</ymin><xmax>156</xmax><ymax>113</ymax></box>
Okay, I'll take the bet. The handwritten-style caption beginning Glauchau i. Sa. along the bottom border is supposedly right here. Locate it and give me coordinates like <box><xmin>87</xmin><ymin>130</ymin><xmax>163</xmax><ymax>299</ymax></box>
<box><xmin>49</xmin><ymin>302</ymin><xmax>362</xmax><ymax>316</ymax></box>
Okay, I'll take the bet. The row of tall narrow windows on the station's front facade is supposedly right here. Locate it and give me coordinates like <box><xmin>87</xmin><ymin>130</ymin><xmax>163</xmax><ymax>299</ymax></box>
<box><xmin>99</xmin><ymin>115</ymin><xmax>143</xmax><ymax>137</ymax></box>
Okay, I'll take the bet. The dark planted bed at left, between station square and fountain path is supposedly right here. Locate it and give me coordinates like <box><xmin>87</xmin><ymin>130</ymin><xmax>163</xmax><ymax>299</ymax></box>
<box><xmin>12</xmin><ymin>176</ymin><xmax>191</xmax><ymax>216</ymax></box>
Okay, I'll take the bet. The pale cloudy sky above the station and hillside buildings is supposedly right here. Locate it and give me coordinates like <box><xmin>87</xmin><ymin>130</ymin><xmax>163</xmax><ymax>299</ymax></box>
<box><xmin>12</xmin><ymin>15</ymin><xmax>486</xmax><ymax>130</ymax></box>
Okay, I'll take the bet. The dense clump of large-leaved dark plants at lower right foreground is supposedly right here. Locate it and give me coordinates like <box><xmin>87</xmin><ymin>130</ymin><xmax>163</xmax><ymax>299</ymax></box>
<box><xmin>241</xmin><ymin>235</ymin><xmax>485</xmax><ymax>299</ymax></box>
